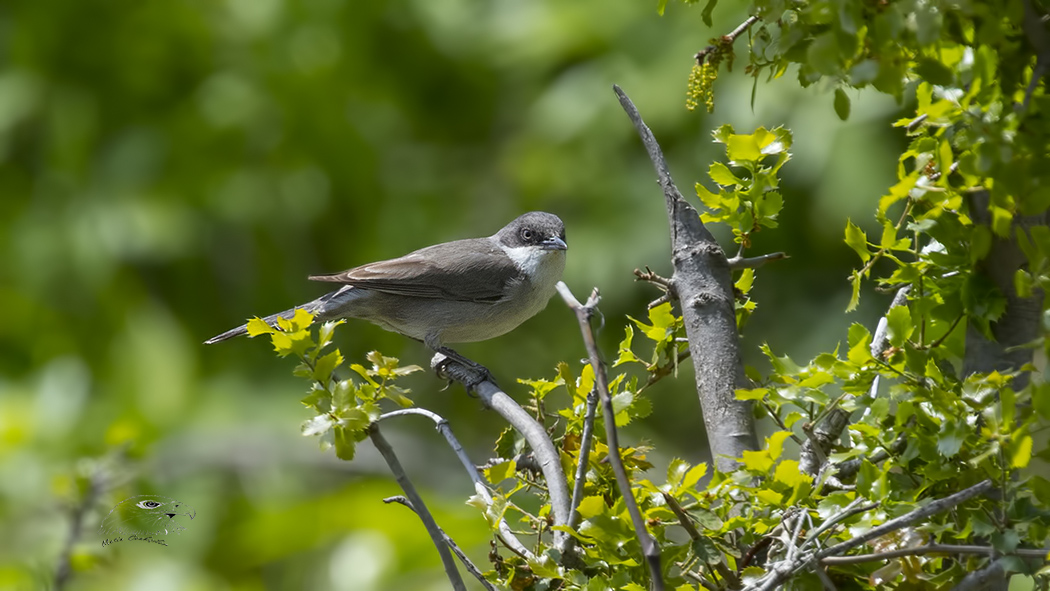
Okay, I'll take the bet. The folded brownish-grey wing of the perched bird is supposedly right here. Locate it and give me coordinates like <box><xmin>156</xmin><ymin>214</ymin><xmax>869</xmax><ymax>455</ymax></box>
<box><xmin>310</xmin><ymin>238</ymin><xmax>521</xmax><ymax>302</ymax></box>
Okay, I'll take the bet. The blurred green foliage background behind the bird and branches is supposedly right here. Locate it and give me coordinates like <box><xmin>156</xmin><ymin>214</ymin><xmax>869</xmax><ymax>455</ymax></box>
<box><xmin>0</xmin><ymin>0</ymin><xmax>904</xmax><ymax>591</ymax></box>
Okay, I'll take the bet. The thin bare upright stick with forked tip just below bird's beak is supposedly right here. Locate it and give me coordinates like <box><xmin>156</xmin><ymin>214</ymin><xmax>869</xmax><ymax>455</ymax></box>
<box><xmin>555</xmin><ymin>281</ymin><xmax>664</xmax><ymax>591</ymax></box>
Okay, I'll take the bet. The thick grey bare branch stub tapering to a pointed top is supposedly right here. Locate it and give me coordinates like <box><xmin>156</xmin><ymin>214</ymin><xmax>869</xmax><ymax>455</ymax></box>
<box><xmin>613</xmin><ymin>83</ymin><xmax>758</xmax><ymax>472</ymax></box>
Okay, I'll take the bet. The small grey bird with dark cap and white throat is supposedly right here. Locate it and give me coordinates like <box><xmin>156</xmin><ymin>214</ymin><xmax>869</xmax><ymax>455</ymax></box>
<box><xmin>205</xmin><ymin>211</ymin><xmax>568</xmax><ymax>360</ymax></box>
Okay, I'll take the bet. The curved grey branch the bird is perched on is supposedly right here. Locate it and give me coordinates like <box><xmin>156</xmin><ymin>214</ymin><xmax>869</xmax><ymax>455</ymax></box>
<box><xmin>431</xmin><ymin>353</ymin><xmax>573</xmax><ymax>557</ymax></box>
